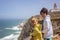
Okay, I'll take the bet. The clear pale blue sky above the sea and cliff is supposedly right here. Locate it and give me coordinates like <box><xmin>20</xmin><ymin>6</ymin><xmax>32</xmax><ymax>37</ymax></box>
<box><xmin>0</xmin><ymin>0</ymin><xmax>60</xmax><ymax>19</ymax></box>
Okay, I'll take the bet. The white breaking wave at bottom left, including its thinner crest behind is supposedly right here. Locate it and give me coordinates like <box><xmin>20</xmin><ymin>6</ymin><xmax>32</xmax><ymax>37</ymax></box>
<box><xmin>0</xmin><ymin>28</ymin><xmax>21</xmax><ymax>40</ymax></box>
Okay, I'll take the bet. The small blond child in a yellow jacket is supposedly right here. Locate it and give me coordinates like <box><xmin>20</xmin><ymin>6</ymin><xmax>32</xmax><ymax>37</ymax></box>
<box><xmin>30</xmin><ymin>18</ymin><xmax>42</xmax><ymax>40</ymax></box>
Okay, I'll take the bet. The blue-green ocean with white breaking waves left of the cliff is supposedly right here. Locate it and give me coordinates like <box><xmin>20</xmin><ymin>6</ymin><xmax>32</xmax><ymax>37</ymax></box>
<box><xmin>0</xmin><ymin>19</ymin><xmax>24</xmax><ymax>40</ymax></box>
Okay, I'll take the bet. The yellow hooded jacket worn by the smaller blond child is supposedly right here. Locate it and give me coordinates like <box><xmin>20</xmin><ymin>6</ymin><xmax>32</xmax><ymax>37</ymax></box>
<box><xmin>31</xmin><ymin>24</ymin><xmax>42</xmax><ymax>40</ymax></box>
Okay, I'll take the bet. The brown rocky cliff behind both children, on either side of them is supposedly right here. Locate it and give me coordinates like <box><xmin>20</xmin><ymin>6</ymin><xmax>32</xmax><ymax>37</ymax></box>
<box><xmin>18</xmin><ymin>12</ymin><xmax>60</xmax><ymax>40</ymax></box>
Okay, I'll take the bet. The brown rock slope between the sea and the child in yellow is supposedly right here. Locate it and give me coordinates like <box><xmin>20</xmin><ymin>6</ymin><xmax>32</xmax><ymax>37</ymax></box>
<box><xmin>18</xmin><ymin>17</ymin><xmax>33</xmax><ymax>40</ymax></box>
